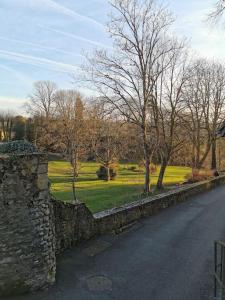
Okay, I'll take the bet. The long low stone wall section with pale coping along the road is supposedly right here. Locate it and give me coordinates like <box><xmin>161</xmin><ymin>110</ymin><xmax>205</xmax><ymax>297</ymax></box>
<box><xmin>94</xmin><ymin>175</ymin><xmax>225</xmax><ymax>234</ymax></box>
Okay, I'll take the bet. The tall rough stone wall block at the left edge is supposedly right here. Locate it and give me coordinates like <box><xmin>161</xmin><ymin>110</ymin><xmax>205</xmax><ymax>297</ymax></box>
<box><xmin>0</xmin><ymin>154</ymin><xmax>56</xmax><ymax>296</ymax></box>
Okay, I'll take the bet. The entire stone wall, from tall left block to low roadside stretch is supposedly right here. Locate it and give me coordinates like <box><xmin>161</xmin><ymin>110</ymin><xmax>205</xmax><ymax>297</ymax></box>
<box><xmin>0</xmin><ymin>154</ymin><xmax>225</xmax><ymax>298</ymax></box>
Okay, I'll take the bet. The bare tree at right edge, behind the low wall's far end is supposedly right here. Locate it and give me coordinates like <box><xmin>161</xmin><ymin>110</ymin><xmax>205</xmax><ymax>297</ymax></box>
<box><xmin>182</xmin><ymin>60</ymin><xmax>224</xmax><ymax>169</ymax></box>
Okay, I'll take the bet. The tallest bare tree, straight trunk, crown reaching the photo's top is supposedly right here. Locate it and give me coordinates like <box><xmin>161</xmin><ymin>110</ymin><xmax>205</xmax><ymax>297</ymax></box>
<box><xmin>89</xmin><ymin>0</ymin><xmax>177</xmax><ymax>193</ymax></box>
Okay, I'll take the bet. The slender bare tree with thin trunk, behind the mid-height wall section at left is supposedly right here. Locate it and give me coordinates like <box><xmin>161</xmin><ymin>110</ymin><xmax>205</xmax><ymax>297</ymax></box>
<box><xmin>55</xmin><ymin>90</ymin><xmax>84</xmax><ymax>201</ymax></box>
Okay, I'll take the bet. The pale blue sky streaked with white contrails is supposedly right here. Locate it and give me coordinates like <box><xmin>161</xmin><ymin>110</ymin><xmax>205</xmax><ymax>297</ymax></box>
<box><xmin>0</xmin><ymin>0</ymin><xmax>225</xmax><ymax>112</ymax></box>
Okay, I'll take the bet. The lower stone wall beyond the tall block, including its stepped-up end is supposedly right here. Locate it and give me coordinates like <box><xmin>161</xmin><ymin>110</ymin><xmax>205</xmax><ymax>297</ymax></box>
<box><xmin>53</xmin><ymin>176</ymin><xmax>225</xmax><ymax>254</ymax></box>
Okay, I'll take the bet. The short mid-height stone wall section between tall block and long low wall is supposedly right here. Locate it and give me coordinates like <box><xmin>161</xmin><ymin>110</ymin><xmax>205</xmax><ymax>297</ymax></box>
<box><xmin>53</xmin><ymin>200</ymin><xmax>97</xmax><ymax>254</ymax></box>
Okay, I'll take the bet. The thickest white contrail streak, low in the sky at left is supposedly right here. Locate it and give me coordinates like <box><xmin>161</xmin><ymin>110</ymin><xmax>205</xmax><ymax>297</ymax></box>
<box><xmin>0</xmin><ymin>50</ymin><xmax>79</xmax><ymax>73</ymax></box>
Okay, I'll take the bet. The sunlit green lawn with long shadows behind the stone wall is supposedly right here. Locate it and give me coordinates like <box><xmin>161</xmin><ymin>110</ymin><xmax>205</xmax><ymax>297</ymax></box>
<box><xmin>49</xmin><ymin>161</ymin><xmax>191</xmax><ymax>213</ymax></box>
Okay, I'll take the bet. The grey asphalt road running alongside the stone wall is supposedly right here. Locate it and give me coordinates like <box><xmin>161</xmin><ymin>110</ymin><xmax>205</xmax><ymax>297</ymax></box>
<box><xmin>6</xmin><ymin>187</ymin><xmax>225</xmax><ymax>300</ymax></box>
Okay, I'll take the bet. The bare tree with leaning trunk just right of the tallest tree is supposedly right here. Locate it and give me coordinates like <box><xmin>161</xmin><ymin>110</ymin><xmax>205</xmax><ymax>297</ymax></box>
<box><xmin>155</xmin><ymin>43</ymin><xmax>188</xmax><ymax>189</ymax></box>
